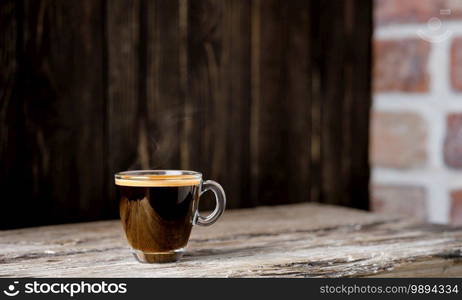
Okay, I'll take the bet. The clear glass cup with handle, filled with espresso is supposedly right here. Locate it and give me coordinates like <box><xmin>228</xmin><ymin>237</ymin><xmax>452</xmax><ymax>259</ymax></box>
<box><xmin>115</xmin><ymin>170</ymin><xmax>226</xmax><ymax>263</ymax></box>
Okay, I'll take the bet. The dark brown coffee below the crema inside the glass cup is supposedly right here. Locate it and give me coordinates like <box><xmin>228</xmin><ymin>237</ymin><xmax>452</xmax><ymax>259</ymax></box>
<box><xmin>119</xmin><ymin>185</ymin><xmax>199</xmax><ymax>253</ymax></box>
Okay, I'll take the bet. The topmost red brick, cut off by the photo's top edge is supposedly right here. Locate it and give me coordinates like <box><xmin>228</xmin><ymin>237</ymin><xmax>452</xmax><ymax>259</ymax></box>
<box><xmin>374</xmin><ymin>0</ymin><xmax>462</xmax><ymax>25</ymax></box>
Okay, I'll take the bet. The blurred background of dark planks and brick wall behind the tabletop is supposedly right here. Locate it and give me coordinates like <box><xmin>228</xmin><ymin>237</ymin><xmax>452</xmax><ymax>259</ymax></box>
<box><xmin>0</xmin><ymin>0</ymin><xmax>462</xmax><ymax>229</ymax></box>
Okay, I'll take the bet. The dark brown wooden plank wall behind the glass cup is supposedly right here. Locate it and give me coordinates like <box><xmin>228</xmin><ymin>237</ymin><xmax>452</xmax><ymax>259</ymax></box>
<box><xmin>0</xmin><ymin>0</ymin><xmax>372</xmax><ymax>229</ymax></box>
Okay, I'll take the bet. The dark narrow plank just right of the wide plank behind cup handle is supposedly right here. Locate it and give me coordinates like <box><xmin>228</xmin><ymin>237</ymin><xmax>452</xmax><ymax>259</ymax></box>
<box><xmin>252</xmin><ymin>0</ymin><xmax>288</xmax><ymax>204</ymax></box>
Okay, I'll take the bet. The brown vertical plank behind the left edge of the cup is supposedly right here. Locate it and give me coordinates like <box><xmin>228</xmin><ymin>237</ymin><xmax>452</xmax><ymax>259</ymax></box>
<box><xmin>104</xmin><ymin>1</ymin><xmax>140</xmax><ymax>217</ymax></box>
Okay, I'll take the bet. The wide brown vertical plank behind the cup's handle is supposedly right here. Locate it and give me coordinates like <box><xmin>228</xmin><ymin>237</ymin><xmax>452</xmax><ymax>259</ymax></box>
<box><xmin>188</xmin><ymin>0</ymin><xmax>250</xmax><ymax>208</ymax></box>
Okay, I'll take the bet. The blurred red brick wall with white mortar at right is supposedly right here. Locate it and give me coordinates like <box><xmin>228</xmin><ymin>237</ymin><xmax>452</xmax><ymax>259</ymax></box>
<box><xmin>371</xmin><ymin>0</ymin><xmax>462</xmax><ymax>224</ymax></box>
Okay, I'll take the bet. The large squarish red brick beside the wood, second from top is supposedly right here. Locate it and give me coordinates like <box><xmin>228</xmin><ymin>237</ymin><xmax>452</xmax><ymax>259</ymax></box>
<box><xmin>373</xmin><ymin>39</ymin><xmax>430</xmax><ymax>92</ymax></box>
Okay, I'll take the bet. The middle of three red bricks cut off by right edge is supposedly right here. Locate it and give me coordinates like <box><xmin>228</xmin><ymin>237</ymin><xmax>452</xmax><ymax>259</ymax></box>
<box><xmin>444</xmin><ymin>113</ymin><xmax>462</xmax><ymax>169</ymax></box>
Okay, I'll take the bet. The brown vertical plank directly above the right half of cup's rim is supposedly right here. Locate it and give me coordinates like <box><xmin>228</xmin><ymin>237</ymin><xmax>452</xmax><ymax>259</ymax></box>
<box><xmin>145</xmin><ymin>0</ymin><xmax>186</xmax><ymax>169</ymax></box>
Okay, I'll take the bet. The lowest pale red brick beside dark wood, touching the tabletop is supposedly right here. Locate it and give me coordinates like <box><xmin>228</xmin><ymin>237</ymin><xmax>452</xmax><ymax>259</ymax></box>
<box><xmin>371</xmin><ymin>184</ymin><xmax>427</xmax><ymax>220</ymax></box>
